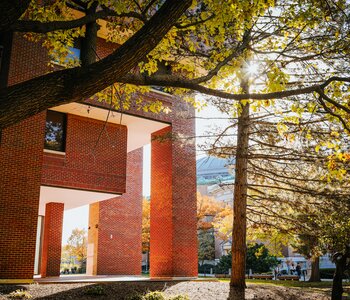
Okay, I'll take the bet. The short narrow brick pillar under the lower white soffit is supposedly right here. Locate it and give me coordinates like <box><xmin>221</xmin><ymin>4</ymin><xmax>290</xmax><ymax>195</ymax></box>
<box><xmin>41</xmin><ymin>202</ymin><xmax>64</xmax><ymax>277</ymax></box>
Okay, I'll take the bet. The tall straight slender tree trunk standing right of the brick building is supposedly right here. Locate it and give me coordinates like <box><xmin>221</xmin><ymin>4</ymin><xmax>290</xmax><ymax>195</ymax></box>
<box><xmin>229</xmin><ymin>81</ymin><xmax>249</xmax><ymax>300</ymax></box>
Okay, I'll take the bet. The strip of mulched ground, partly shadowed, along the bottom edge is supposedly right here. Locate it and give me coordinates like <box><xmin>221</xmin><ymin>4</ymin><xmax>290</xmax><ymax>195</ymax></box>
<box><xmin>0</xmin><ymin>281</ymin><xmax>340</xmax><ymax>300</ymax></box>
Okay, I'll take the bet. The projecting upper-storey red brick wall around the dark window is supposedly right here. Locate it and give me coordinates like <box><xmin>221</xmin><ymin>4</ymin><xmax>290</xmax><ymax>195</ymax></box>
<box><xmin>42</xmin><ymin>114</ymin><xmax>127</xmax><ymax>193</ymax></box>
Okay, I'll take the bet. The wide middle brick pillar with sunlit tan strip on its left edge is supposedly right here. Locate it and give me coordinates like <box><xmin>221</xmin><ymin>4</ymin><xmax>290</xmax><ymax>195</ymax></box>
<box><xmin>87</xmin><ymin>148</ymin><xmax>143</xmax><ymax>275</ymax></box>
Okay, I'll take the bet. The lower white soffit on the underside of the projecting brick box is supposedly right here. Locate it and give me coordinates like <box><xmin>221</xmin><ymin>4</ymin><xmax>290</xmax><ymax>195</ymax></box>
<box><xmin>39</xmin><ymin>186</ymin><xmax>119</xmax><ymax>216</ymax></box>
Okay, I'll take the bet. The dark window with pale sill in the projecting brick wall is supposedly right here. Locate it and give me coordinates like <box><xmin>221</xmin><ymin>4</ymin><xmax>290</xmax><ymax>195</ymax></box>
<box><xmin>45</xmin><ymin>110</ymin><xmax>66</xmax><ymax>152</ymax></box>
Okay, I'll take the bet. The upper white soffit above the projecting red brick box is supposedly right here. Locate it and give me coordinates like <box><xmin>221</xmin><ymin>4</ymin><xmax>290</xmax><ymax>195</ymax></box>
<box><xmin>52</xmin><ymin>103</ymin><xmax>169</xmax><ymax>152</ymax></box>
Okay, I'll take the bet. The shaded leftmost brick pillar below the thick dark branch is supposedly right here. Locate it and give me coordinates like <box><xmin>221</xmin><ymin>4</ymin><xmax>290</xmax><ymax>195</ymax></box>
<box><xmin>0</xmin><ymin>113</ymin><xmax>46</xmax><ymax>281</ymax></box>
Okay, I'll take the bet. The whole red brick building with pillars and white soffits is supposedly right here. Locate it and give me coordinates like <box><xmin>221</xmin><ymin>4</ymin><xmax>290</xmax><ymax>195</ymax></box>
<box><xmin>0</xmin><ymin>35</ymin><xmax>197</xmax><ymax>282</ymax></box>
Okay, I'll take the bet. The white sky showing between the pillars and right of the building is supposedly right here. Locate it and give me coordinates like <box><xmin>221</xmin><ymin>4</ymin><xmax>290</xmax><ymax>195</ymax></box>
<box><xmin>62</xmin><ymin>107</ymin><xmax>226</xmax><ymax>245</ymax></box>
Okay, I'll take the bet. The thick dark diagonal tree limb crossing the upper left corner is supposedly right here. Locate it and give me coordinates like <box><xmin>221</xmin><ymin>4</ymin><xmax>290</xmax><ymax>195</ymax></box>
<box><xmin>0</xmin><ymin>0</ymin><xmax>192</xmax><ymax>128</ymax></box>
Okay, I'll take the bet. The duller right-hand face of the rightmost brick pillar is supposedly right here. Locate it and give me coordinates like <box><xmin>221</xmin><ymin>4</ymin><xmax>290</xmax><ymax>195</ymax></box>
<box><xmin>172</xmin><ymin>103</ymin><xmax>198</xmax><ymax>277</ymax></box>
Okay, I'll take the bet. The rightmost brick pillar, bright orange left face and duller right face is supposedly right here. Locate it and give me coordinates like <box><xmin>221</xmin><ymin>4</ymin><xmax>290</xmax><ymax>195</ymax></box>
<box><xmin>150</xmin><ymin>118</ymin><xmax>198</xmax><ymax>277</ymax></box>
